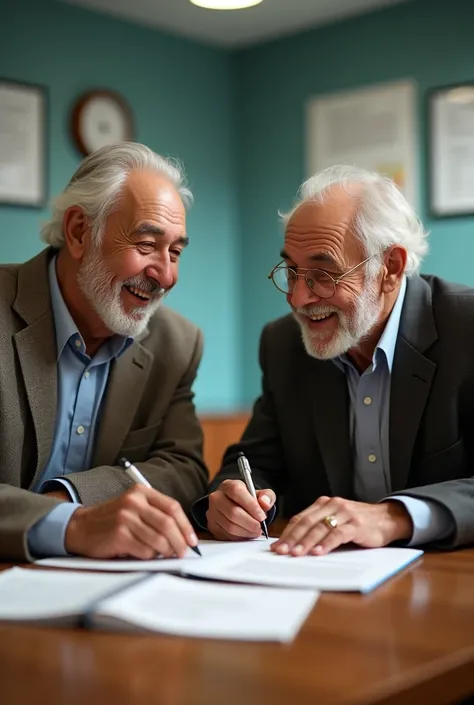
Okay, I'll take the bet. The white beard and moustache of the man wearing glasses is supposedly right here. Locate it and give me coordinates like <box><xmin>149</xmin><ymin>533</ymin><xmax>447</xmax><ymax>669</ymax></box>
<box><xmin>294</xmin><ymin>284</ymin><xmax>381</xmax><ymax>360</ymax></box>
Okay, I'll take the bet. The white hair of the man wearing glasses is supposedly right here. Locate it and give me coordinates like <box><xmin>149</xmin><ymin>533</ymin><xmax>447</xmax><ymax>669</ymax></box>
<box><xmin>280</xmin><ymin>165</ymin><xmax>428</xmax><ymax>276</ymax></box>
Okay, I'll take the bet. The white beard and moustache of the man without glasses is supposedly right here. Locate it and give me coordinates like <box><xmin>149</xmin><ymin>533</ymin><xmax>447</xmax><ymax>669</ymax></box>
<box><xmin>77</xmin><ymin>248</ymin><xmax>166</xmax><ymax>338</ymax></box>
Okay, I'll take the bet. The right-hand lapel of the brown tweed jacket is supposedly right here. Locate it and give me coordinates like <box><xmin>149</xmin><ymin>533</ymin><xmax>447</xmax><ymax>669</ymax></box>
<box><xmin>93</xmin><ymin>342</ymin><xmax>154</xmax><ymax>467</ymax></box>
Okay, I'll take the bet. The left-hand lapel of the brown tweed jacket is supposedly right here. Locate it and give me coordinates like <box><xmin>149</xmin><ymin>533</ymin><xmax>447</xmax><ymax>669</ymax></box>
<box><xmin>13</xmin><ymin>249</ymin><xmax>57</xmax><ymax>484</ymax></box>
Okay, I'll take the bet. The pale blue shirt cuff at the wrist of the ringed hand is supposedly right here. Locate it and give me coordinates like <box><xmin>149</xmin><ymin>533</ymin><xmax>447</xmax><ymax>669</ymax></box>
<box><xmin>387</xmin><ymin>495</ymin><xmax>454</xmax><ymax>546</ymax></box>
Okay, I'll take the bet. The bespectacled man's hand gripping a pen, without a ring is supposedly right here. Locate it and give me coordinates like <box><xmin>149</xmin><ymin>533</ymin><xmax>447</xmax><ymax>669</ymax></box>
<box><xmin>206</xmin><ymin>480</ymin><xmax>276</xmax><ymax>541</ymax></box>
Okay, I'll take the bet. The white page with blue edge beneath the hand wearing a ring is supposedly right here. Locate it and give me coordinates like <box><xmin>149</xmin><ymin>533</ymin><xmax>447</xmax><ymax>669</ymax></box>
<box><xmin>187</xmin><ymin>545</ymin><xmax>423</xmax><ymax>593</ymax></box>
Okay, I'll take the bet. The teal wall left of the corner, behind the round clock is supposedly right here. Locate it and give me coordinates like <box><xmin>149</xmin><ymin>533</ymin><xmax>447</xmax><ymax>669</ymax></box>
<box><xmin>0</xmin><ymin>0</ymin><xmax>239</xmax><ymax>411</ymax></box>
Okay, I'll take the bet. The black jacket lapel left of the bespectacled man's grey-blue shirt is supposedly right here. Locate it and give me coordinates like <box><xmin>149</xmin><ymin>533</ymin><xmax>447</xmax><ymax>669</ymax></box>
<box><xmin>307</xmin><ymin>356</ymin><xmax>354</xmax><ymax>499</ymax></box>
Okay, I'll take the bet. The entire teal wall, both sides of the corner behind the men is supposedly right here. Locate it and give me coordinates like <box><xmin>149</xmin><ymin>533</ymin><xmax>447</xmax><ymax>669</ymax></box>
<box><xmin>0</xmin><ymin>0</ymin><xmax>474</xmax><ymax>411</ymax></box>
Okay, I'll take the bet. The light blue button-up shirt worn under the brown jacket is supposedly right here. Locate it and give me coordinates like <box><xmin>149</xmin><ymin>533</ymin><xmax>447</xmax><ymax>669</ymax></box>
<box><xmin>28</xmin><ymin>257</ymin><xmax>133</xmax><ymax>556</ymax></box>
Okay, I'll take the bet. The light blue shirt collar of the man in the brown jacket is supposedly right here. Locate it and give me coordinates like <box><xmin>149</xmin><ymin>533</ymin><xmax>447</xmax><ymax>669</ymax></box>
<box><xmin>48</xmin><ymin>255</ymin><xmax>133</xmax><ymax>360</ymax></box>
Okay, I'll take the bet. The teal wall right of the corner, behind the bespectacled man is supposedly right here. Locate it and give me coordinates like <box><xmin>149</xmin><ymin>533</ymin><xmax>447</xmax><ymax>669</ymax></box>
<box><xmin>235</xmin><ymin>0</ymin><xmax>474</xmax><ymax>402</ymax></box>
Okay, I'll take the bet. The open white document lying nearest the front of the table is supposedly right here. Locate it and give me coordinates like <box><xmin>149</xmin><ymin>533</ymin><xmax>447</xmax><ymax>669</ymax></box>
<box><xmin>0</xmin><ymin>568</ymin><xmax>318</xmax><ymax>642</ymax></box>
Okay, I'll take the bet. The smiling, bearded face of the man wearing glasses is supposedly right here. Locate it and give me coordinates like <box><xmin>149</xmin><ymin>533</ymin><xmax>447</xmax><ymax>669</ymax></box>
<box><xmin>282</xmin><ymin>187</ymin><xmax>381</xmax><ymax>360</ymax></box>
